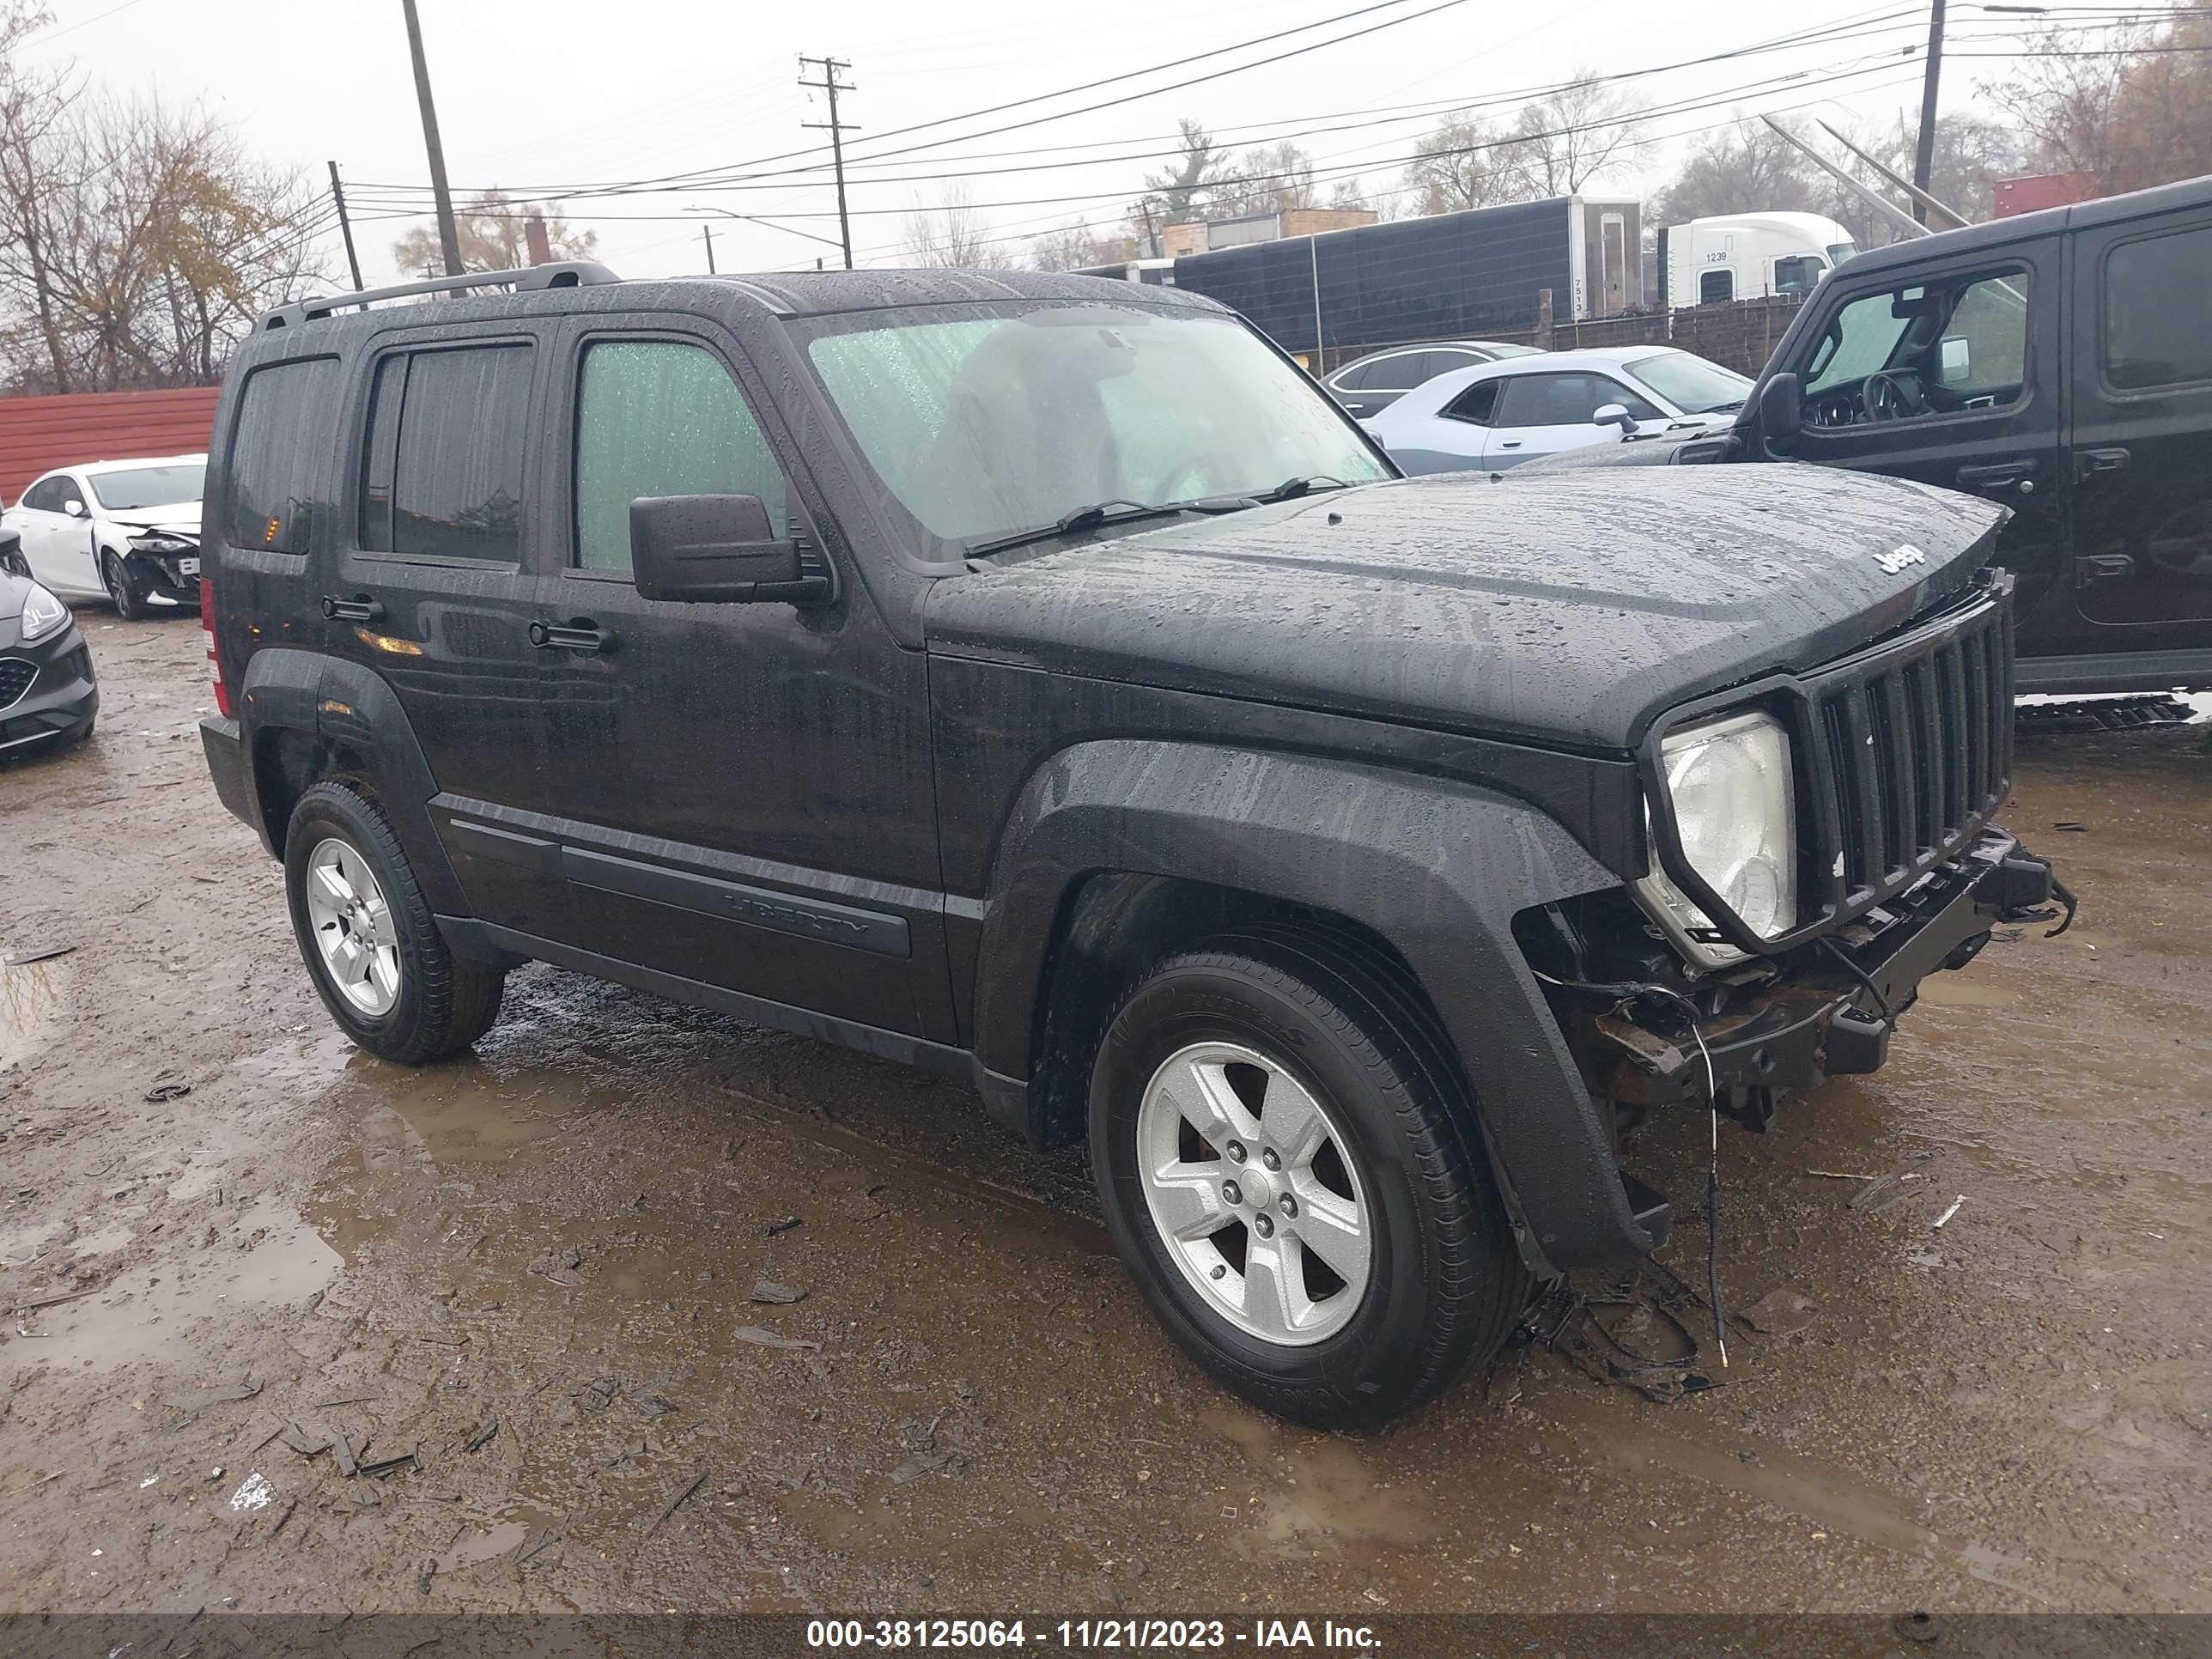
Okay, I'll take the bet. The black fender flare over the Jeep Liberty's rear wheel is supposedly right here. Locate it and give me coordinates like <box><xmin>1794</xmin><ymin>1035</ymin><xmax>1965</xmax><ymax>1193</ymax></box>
<box><xmin>239</xmin><ymin>646</ymin><xmax>469</xmax><ymax>915</ymax></box>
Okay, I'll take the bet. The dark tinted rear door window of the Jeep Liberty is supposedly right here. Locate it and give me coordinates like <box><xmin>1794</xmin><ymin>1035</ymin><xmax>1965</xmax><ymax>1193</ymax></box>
<box><xmin>361</xmin><ymin>345</ymin><xmax>531</xmax><ymax>564</ymax></box>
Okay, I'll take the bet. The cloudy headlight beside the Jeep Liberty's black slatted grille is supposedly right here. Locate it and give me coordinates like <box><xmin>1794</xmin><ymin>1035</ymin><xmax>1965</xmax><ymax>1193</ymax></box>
<box><xmin>1644</xmin><ymin>714</ymin><xmax>1796</xmax><ymax>963</ymax></box>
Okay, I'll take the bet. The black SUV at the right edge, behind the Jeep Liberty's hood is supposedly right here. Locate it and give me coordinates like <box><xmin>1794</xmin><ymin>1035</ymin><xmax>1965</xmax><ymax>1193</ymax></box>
<box><xmin>1516</xmin><ymin>179</ymin><xmax>2212</xmax><ymax>692</ymax></box>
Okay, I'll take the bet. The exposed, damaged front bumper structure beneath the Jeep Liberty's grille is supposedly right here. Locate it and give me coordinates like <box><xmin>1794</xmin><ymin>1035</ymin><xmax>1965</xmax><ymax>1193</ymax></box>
<box><xmin>1595</xmin><ymin>827</ymin><xmax>2070</xmax><ymax>1128</ymax></box>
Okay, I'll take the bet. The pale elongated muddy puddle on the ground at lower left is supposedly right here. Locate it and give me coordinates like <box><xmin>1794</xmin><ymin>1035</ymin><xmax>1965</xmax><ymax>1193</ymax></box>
<box><xmin>15</xmin><ymin>1206</ymin><xmax>341</xmax><ymax>1371</ymax></box>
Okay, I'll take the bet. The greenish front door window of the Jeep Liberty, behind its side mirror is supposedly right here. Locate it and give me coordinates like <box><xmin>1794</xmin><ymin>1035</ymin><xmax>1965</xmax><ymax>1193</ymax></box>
<box><xmin>575</xmin><ymin>341</ymin><xmax>785</xmax><ymax>571</ymax></box>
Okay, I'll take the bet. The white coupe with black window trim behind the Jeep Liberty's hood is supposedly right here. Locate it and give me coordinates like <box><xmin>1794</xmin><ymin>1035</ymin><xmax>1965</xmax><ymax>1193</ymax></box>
<box><xmin>1360</xmin><ymin>345</ymin><xmax>1752</xmax><ymax>473</ymax></box>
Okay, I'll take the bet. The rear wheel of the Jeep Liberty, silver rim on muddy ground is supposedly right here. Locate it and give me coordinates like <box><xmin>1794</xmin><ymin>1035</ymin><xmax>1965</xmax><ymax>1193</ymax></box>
<box><xmin>285</xmin><ymin>781</ymin><xmax>507</xmax><ymax>1066</ymax></box>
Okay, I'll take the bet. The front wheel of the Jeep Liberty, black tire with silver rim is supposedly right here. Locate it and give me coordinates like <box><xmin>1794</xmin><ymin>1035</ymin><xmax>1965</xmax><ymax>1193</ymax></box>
<box><xmin>1091</xmin><ymin>931</ymin><xmax>1528</xmax><ymax>1429</ymax></box>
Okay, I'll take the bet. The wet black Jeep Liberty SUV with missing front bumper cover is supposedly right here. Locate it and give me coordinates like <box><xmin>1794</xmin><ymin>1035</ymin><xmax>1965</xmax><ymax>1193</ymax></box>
<box><xmin>201</xmin><ymin>265</ymin><xmax>2063</xmax><ymax>1427</ymax></box>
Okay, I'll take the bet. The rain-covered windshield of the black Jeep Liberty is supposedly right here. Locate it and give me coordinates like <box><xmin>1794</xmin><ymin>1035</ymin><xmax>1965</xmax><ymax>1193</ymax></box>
<box><xmin>807</xmin><ymin>303</ymin><xmax>1389</xmax><ymax>542</ymax></box>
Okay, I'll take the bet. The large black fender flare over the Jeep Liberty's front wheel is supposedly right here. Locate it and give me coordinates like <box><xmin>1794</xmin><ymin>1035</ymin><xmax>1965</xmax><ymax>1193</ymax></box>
<box><xmin>975</xmin><ymin>738</ymin><xmax>1659</xmax><ymax>1272</ymax></box>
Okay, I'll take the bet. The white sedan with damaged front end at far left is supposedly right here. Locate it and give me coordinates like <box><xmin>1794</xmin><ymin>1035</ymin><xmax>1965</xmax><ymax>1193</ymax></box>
<box><xmin>0</xmin><ymin>456</ymin><xmax>208</xmax><ymax>617</ymax></box>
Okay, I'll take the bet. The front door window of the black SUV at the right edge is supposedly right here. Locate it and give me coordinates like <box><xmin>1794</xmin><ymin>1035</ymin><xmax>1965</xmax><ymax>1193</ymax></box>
<box><xmin>1805</xmin><ymin>270</ymin><xmax>2028</xmax><ymax>425</ymax></box>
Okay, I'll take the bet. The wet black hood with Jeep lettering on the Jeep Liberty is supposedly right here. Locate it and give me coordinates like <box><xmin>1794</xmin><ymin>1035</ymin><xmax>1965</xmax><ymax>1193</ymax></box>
<box><xmin>927</xmin><ymin>465</ymin><xmax>2006</xmax><ymax>750</ymax></box>
